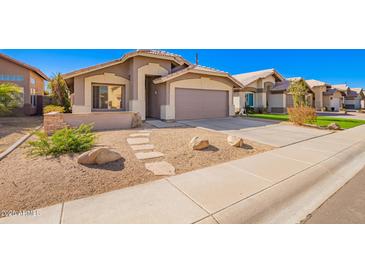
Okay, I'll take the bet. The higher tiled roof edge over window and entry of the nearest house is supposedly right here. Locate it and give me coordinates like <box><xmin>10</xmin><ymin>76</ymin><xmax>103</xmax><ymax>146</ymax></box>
<box><xmin>62</xmin><ymin>49</ymin><xmax>190</xmax><ymax>79</ymax></box>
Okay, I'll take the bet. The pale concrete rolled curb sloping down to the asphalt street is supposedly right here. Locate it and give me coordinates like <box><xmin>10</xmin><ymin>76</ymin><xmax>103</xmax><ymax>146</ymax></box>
<box><xmin>213</xmin><ymin>141</ymin><xmax>365</xmax><ymax>224</ymax></box>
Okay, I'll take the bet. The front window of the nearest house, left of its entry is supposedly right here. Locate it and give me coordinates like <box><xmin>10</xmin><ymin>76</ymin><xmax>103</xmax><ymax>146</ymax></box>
<box><xmin>92</xmin><ymin>84</ymin><xmax>125</xmax><ymax>110</ymax></box>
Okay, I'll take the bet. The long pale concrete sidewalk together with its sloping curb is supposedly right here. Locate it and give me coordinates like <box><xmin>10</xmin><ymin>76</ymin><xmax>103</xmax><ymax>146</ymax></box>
<box><xmin>0</xmin><ymin>126</ymin><xmax>365</xmax><ymax>223</ymax></box>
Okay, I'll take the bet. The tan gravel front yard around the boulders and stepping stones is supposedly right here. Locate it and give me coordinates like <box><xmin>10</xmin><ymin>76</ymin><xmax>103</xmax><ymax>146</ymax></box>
<box><xmin>0</xmin><ymin>128</ymin><xmax>271</xmax><ymax>210</ymax></box>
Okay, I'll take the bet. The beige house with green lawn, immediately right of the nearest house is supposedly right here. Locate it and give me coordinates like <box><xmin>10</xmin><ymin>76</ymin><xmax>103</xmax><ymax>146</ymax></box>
<box><xmin>233</xmin><ymin>69</ymin><xmax>286</xmax><ymax>112</ymax></box>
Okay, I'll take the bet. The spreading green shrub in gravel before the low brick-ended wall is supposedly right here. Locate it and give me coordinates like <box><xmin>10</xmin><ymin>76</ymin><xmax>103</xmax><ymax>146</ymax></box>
<box><xmin>29</xmin><ymin>125</ymin><xmax>95</xmax><ymax>156</ymax></box>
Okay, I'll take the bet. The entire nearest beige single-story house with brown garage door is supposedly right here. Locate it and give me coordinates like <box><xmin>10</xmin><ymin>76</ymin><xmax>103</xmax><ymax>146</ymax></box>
<box><xmin>63</xmin><ymin>50</ymin><xmax>243</xmax><ymax>120</ymax></box>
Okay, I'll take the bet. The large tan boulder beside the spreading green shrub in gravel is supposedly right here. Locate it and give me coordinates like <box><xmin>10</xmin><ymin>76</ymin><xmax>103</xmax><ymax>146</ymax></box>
<box><xmin>77</xmin><ymin>147</ymin><xmax>122</xmax><ymax>165</ymax></box>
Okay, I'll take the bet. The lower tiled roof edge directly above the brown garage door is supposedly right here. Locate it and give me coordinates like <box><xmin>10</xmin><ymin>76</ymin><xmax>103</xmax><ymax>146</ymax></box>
<box><xmin>153</xmin><ymin>65</ymin><xmax>243</xmax><ymax>88</ymax></box>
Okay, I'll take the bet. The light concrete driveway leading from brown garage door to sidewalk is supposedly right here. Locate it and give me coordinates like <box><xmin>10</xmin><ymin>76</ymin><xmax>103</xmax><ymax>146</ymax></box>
<box><xmin>179</xmin><ymin>117</ymin><xmax>331</xmax><ymax>147</ymax></box>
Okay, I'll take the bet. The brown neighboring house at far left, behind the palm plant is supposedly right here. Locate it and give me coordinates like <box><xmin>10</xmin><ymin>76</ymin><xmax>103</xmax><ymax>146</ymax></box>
<box><xmin>0</xmin><ymin>53</ymin><xmax>48</xmax><ymax>115</ymax></box>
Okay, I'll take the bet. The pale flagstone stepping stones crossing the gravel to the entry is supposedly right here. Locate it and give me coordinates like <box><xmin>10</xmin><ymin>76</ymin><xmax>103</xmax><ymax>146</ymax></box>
<box><xmin>127</xmin><ymin>130</ymin><xmax>175</xmax><ymax>176</ymax></box>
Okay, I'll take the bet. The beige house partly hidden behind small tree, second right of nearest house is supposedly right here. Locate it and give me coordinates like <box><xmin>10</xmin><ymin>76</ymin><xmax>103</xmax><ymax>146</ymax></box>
<box><xmin>269</xmin><ymin>77</ymin><xmax>314</xmax><ymax>113</ymax></box>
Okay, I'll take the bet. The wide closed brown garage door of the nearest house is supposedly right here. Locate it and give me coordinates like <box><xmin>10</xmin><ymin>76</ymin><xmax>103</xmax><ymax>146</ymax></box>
<box><xmin>175</xmin><ymin>88</ymin><xmax>228</xmax><ymax>120</ymax></box>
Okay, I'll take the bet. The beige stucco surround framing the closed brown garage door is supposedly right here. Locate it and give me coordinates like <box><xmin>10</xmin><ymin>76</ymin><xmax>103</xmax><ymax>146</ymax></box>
<box><xmin>160</xmin><ymin>73</ymin><xmax>234</xmax><ymax>120</ymax></box>
